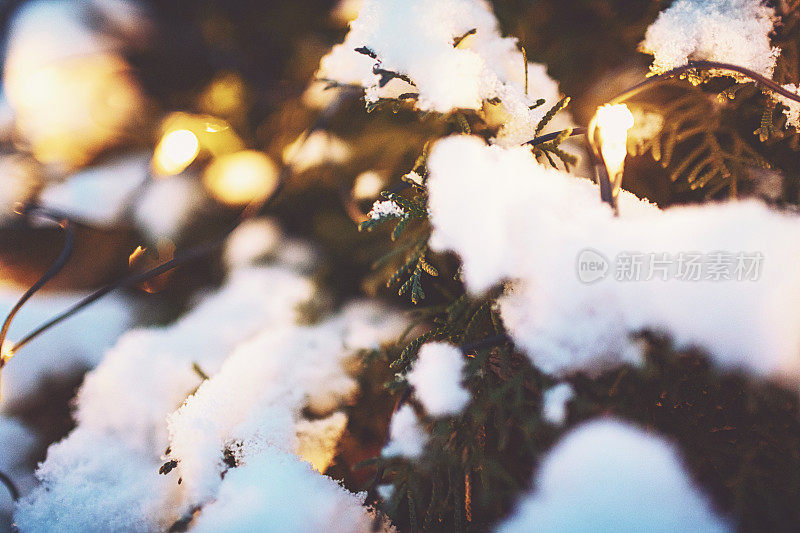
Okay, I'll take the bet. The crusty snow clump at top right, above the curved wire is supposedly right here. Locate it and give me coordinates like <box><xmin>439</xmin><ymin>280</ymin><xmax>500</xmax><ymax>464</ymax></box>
<box><xmin>641</xmin><ymin>0</ymin><xmax>780</xmax><ymax>78</ymax></box>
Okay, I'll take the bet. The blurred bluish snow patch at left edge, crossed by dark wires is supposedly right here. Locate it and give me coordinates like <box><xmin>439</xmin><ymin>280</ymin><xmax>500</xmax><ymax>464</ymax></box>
<box><xmin>0</xmin><ymin>285</ymin><xmax>136</xmax><ymax>412</ymax></box>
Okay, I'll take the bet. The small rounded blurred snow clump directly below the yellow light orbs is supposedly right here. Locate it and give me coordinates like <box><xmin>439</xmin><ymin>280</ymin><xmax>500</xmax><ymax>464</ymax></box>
<box><xmin>134</xmin><ymin>175</ymin><xmax>208</xmax><ymax>242</ymax></box>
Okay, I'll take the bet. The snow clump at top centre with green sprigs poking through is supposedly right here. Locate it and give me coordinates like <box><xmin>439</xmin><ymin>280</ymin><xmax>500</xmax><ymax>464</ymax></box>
<box><xmin>317</xmin><ymin>0</ymin><xmax>569</xmax><ymax>145</ymax></box>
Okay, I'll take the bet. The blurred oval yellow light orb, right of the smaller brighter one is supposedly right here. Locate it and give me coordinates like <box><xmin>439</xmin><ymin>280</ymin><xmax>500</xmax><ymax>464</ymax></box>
<box><xmin>203</xmin><ymin>150</ymin><xmax>278</xmax><ymax>206</ymax></box>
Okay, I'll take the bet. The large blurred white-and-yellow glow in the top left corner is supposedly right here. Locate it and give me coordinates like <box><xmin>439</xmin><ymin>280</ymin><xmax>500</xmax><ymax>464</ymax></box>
<box><xmin>3</xmin><ymin>2</ymin><xmax>144</xmax><ymax>169</ymax></box>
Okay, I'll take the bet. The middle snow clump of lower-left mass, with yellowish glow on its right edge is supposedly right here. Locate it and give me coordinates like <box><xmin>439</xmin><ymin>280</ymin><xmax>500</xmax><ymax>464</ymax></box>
<box><xmin>168</xmin><ymin>302</ymin><xmax>404</xmax><ymax>504</ymax></box>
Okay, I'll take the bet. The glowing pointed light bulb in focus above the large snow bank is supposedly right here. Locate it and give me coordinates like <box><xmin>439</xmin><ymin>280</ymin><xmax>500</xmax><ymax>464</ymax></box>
<box><xmin>589</xmin><ymin>104</ymin><xmax>634</xmax><ymax>205</ymax></box>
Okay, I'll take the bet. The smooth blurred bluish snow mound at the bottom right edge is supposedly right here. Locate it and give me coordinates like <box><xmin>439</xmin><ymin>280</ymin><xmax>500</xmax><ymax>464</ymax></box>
<box><xmin>497</xmin><ymin>420</ymin><xmax>732</xmax><ymax>533</ymax></box>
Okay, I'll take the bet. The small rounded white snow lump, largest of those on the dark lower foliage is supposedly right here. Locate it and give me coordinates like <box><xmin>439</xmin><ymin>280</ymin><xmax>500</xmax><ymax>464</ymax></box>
<box><xmin>407</xmin><ymin>342</ymin><xmax>472</xmax><ymax>417</ymax></box>
